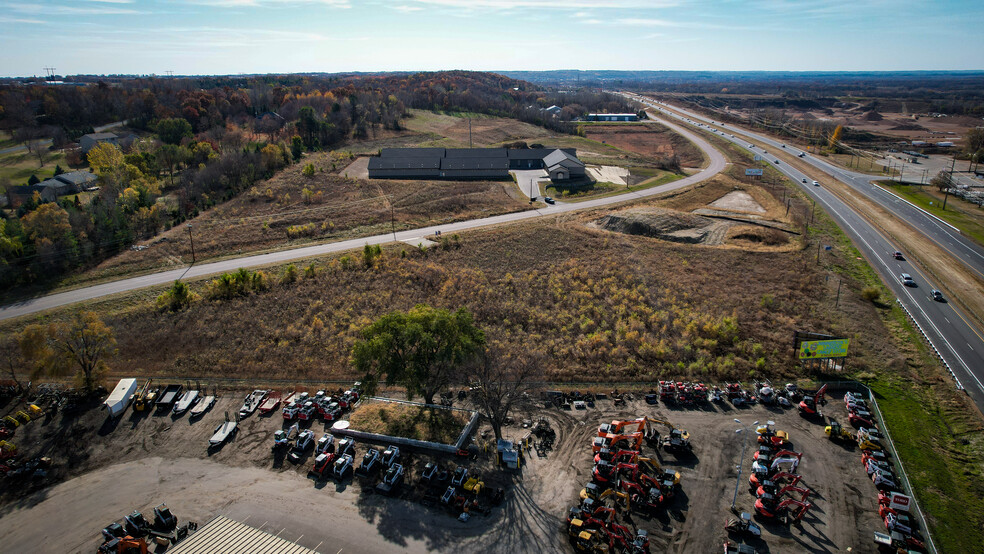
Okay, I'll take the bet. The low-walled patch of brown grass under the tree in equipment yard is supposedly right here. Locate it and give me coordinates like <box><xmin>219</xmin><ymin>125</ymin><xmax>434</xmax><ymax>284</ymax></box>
<box><xmin>348</xmin><ymin>402</ymin><xmax>468</xmax><ymax>444</ymax></box>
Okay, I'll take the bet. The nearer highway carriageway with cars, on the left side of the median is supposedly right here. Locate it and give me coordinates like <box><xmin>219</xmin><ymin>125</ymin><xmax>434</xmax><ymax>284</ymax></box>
<box><xmin>628</xmin><ymin>91</ymin><xmax>984</xmax><ymax>410</ymax></box>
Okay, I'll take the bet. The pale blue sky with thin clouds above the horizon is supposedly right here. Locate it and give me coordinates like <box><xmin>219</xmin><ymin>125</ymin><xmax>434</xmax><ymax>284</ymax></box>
<box><xmin>0</xmin><ymin>0</ymin><xmax>984</xmax><ymax>77</ymax></box>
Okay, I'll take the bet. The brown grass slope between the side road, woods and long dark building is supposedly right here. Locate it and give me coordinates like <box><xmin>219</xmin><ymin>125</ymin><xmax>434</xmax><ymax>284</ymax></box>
<box><xmin>80</xmin><ymin>154</ymin><xmax>528</xmax><ymax>280</ymax></box>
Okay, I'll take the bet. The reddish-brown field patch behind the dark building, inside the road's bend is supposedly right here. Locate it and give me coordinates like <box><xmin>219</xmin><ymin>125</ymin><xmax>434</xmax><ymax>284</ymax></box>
<box><xmin>584</xmin><ymin>123</ymin><xmax>704</xmax><ymax>167</ymax></box>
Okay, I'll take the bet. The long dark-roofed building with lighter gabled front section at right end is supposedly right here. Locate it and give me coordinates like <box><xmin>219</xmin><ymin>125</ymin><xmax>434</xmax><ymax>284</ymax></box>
<box><xmin>369</xmin><ymin>148</ymin><xmax>585</xmax><ymax>181</ymax></box>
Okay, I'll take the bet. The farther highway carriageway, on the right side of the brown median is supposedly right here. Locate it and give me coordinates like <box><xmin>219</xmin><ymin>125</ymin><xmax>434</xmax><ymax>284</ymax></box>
<box><xmin>632</xmin><ymin>94</ymin><xmax>984</xmax><ymax>279</ymax></box>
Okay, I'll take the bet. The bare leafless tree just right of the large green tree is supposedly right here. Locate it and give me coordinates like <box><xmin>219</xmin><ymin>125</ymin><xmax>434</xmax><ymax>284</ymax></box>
<box><xmin>462</xmin><ymin>346</ymin><xmax>542</xmax><ymax>439</ymax></box>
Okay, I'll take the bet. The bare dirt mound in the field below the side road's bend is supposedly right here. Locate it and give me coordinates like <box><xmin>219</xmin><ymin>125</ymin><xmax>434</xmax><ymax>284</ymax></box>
<box><xmin>598</xmin><ymin>210</ymin><xmax>721</xmax><ymax>244</ymax></box>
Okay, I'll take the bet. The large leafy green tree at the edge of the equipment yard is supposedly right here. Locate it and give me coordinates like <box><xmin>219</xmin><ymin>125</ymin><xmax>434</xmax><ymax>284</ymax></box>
<box><xmin>352</xmin><ymin>304</ymin><xmax>485</xmax><ymax>404</ymax></box>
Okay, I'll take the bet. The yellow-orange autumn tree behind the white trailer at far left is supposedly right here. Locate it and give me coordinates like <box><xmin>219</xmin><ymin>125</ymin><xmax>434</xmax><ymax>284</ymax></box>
<box><xmin>18</xmin><ymin>311</ymin><xmax>116</xmax><ymax>392</ymax></box>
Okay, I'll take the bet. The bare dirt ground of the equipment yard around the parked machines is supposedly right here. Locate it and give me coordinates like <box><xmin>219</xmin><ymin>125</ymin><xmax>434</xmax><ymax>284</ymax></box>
<box><xmin>0</xmin><ymin>388</ymin><xmax>880</xmax><ymax>553</ymax></box>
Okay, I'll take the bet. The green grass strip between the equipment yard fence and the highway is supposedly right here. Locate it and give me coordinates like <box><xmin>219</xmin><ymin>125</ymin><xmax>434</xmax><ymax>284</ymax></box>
<box><xmin>810</xmin><ymin>183</ymin><xmax>984</xmax><ymax>552</ymax></box>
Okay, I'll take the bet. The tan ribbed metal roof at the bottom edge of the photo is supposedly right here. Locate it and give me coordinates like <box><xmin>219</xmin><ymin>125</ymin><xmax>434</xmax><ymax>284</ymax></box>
<box><xmin>168</xmin><ymin>516</ymin><xmax>317</xmax><ymax>554</ymax></box>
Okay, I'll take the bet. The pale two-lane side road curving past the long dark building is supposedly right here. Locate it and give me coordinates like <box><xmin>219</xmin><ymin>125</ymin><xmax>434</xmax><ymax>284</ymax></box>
<box><xmin>0</xmin><ymin>117</ymin><xmax>727</xmax><ymax>320</ymax></box>
